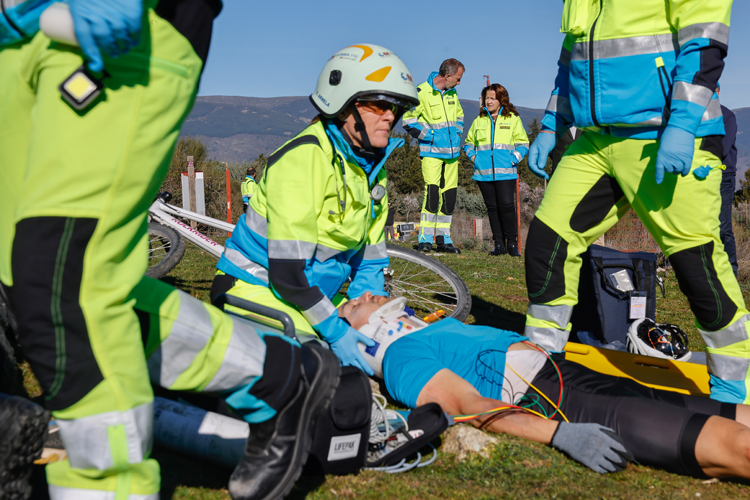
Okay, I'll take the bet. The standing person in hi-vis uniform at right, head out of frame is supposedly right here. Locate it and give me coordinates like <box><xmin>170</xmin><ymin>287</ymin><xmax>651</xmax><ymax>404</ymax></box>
<box><xmin>525</xmin><ymin>0</ymin><xmax>750</xmax><ymax>404</ymax></box>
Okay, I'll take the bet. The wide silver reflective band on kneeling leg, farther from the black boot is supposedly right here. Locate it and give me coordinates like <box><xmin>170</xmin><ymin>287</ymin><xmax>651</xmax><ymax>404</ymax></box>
<box><xmin>147</xmin><ymin>294</ymin><xmax>213</xmax><ymax>389</ymax></box>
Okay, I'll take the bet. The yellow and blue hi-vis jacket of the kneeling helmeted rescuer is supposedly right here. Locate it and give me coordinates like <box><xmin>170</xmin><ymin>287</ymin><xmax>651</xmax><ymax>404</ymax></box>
<box><xmin>217</xmin><ymin>120</ymin><xmax>403</xmax><ymax>327</ymax></box>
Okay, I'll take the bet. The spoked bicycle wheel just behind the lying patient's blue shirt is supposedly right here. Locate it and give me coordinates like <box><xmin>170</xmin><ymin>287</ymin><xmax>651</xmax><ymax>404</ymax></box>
<box><xmin>385</xmin><ymin>245</ymin><xmax>471</xmax><ymax>321</ymax></box>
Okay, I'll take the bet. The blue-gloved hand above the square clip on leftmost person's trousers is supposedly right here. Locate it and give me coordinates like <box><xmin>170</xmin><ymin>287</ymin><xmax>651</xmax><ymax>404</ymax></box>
<box><xmin>69</xmin><ymin>0</ymin><xmax>143</xmax><ymax>72</ymax></box>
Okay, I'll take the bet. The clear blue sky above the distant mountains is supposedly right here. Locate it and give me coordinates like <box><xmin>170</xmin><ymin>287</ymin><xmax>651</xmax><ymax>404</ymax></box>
<box><xmin>199</xmin><ymin>0</ymin><xmax>750</xmax><ymax>109</ymax></box>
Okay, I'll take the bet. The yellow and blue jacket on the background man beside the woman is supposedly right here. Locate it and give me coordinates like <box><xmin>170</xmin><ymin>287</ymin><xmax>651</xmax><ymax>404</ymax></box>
<box><xmin>402</xmin><ymin>71</ymin><xmax>464</xmax><ymax>159</ymax></box>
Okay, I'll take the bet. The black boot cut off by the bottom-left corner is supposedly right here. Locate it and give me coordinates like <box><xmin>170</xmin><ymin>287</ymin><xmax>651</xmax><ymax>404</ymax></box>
<box><xmin>0</xmin><ymin>394</ymin><xmax>49</xmax><ymax>500</ymax></box>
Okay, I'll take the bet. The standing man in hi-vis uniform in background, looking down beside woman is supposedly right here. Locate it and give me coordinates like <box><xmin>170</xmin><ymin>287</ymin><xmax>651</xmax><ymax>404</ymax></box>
<box><xmin>403</xmin><ymin>59</ymin><xmax>464</xmax><ymax>253</ymax></box>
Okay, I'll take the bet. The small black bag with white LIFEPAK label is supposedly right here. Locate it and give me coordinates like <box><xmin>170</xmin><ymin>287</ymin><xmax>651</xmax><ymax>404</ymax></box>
<box><xmin>305</xmin><ymin>366</ymin><xmax>372</xmax><ymax>475</ymax></box>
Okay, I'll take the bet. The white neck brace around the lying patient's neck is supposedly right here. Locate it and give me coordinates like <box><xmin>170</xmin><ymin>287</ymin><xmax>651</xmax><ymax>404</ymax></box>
<box><xmin>359</xmin><ymin>297</ymin><xmax>427</xmax><ymax>378</ymax></box>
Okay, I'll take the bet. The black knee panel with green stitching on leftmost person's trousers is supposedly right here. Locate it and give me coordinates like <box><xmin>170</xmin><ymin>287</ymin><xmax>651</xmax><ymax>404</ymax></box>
<box><xmin>11</xmin><ymin>217</ymin><xmax>103</xmax><ymax>410</ymax></box>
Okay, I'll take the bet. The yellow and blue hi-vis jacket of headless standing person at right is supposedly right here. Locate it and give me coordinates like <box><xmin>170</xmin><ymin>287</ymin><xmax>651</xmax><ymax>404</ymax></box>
<box><xmin>542</xmin><ymin>0</ymin><xmax>732</xmax><ymax>139</ymax></box>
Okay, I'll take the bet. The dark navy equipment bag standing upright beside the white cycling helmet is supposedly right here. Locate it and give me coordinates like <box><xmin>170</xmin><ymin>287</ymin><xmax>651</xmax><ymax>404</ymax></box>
<box><xmin>571</xmin><ymin>245</ymin><xmax>664</xmax><ymax>344</ymax></box>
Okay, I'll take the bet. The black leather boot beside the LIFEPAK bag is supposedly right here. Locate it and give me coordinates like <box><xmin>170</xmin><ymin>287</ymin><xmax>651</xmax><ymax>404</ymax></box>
<box><xmin>229</xmin><ymin>342</ymin><xmax>341</xmax><ymax>500</ymax></box>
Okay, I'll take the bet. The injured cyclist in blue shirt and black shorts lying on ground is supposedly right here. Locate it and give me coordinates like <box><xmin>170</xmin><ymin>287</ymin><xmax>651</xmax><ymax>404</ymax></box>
<box><xmin>339</xmin><ymin>293</ymin><xmax>750</xmax><ymax>478</ymax></box>
